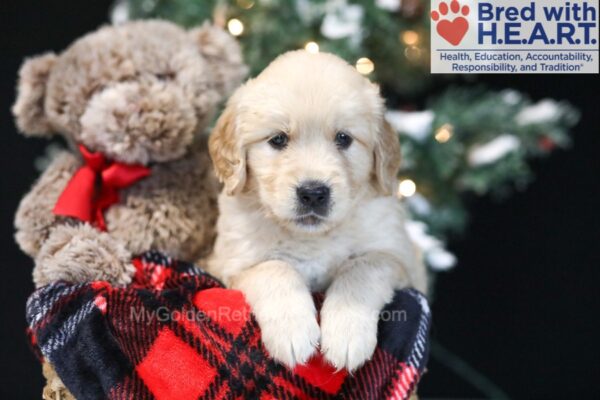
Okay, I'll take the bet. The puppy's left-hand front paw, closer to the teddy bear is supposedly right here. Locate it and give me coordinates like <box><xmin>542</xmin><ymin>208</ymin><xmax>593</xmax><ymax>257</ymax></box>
<box><xmin>254</xmin><ymin>303</ymin><xmax>321</xmax><ymax>368</ymax></box>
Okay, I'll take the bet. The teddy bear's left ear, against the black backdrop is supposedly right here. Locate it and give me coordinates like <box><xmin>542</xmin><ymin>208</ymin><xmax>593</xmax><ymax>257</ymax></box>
<box><xmin>12</xmin><ymin>53</ymin><xmax>57</xmax><ymax>136</ymax></box>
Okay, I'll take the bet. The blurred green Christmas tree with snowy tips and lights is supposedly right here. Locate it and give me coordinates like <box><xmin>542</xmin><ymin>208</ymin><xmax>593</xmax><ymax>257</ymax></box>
<box><xmin>112</xmin><ymin>0</ymin><xmax>578</xmax><ymax>271</ymax></box>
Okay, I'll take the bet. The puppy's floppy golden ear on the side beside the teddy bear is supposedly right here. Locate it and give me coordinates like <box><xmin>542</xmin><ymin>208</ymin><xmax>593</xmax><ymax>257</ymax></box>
<box><xmin>208</xmin><ymin>101</ymin><xmax>246</xmax><ymax>195</ymax></box>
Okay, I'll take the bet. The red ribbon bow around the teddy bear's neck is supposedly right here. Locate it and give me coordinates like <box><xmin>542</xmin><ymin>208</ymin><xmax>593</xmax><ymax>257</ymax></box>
<box><xmin>52</xmin><ymin>145</ymin><xmax>150</xmax><ymax>231</ymax></box>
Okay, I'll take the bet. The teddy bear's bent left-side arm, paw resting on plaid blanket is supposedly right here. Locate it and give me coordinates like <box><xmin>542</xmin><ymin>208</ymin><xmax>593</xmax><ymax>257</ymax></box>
<box><xmin>15</xmin><ymin>151</ymin><xmax>135</xmax><ymax>287</ymax></box>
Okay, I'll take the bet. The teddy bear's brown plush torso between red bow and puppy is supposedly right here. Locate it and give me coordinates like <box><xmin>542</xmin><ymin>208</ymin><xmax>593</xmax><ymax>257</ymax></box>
<box><xmin>106</xmin><ymin>140</ymin><xmax>220</xmax><ymax>261</ymax></box>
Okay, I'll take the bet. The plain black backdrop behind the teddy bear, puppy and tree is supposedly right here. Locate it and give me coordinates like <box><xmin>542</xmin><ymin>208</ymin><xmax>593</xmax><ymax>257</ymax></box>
<box><xmin>0</xmin><ymin>0</ymin><xmax>600</xmax><ymax>399</ymax></box>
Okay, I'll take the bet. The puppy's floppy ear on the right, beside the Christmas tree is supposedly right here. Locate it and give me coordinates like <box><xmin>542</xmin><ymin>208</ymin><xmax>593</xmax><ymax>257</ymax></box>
<box><xmin>375</xmin><ymin>119</ymin><xmax>400</xmax><ymax>196</ymax></box>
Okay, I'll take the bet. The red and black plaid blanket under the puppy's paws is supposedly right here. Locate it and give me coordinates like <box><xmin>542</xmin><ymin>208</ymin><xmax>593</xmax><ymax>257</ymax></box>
<box><xmin>27</xmin><ymin>252</ymin><xmax>430</xmax><ymax>400</ymax></box>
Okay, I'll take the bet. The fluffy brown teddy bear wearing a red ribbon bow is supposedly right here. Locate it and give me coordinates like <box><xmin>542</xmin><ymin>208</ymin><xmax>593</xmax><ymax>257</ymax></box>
<box><xmin>12</xmin><ymin>20</ymin><xmax>247</xmax><ymax>287</ymax></box>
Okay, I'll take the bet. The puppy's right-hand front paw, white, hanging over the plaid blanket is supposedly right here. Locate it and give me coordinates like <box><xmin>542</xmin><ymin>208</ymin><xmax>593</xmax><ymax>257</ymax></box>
<box><xmin>321</xmin><ymin>300</ymin><xmax>378</xmax><ymax>371</ymax></box>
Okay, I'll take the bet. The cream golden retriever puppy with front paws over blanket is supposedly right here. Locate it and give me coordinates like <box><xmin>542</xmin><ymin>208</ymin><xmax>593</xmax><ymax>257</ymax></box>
<box><xmin>208</xmin><ymin>51</ymin><xmax>425</xmax><ymax>370</ymax></box>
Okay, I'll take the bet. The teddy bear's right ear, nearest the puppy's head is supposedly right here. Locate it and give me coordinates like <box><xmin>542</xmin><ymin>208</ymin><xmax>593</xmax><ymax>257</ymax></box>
<box><xmin>189</xmin><ymin>23</ymin><xmax>248</xmax><ymax>96</ymax></box>
